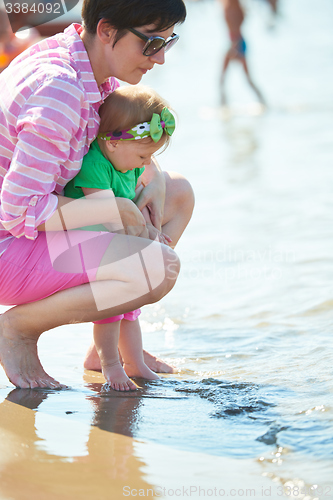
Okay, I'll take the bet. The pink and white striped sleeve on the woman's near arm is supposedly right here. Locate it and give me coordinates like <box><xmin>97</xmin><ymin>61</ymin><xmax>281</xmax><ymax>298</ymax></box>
<box><xmin>0</xmin><ymin>76</ymin><xmax>83</xmax><ymax>239</ymax></box>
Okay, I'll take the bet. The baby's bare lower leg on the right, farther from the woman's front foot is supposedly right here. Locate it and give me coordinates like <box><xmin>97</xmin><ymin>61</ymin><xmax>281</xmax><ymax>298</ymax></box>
<box><xmin>118</xmin><ymin>319</ymin><xmax>159</xmax><ymax>380</ymax></box>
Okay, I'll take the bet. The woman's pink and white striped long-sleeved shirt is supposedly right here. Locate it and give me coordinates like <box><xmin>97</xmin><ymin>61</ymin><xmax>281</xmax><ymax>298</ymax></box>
<box><xmin>0</xmin><ymin>24</ymin><xmax>119</xmax><ymax>256</ymax></box>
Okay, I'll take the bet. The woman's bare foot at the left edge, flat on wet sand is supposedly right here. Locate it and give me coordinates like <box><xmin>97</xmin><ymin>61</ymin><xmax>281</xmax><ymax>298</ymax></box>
<box><xmin>0</xmin><ymin>315</ymin><xmax>66</xmax><ymax>389</ymax></box>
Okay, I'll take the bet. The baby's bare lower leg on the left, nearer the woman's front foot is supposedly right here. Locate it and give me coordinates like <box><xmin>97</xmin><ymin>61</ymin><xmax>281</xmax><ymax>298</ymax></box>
<box><xmin>94</xmin><ymin>321</ymin><xmax>137</xmax><ymax>391</ymax></box>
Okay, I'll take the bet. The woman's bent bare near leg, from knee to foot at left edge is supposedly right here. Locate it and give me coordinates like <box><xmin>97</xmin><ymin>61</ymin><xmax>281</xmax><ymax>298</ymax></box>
<box><xmin>0</xmin><ymin>235</ymin><xmax>179</xmax><ymax>388</ymax></box>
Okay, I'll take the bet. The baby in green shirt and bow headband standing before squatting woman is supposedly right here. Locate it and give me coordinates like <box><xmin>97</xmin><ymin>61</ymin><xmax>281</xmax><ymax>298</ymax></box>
<box><xmin>65</xmin><ymin>86</ymin><xmax>175</xmax><ymax>391</ymax></box>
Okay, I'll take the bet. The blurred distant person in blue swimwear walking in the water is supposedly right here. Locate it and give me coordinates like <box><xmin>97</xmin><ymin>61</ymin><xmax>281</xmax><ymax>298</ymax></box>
<box><xmin>220</xmin><ymin>0</ymin><xmax>265</xmax><ymax>105</ymax></box>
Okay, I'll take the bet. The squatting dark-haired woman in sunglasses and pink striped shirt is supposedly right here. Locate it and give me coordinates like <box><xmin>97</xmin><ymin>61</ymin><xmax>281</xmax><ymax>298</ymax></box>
<box><xmin>0</xmin><ymin>0</ymin><xmax>193</xmax><ymax>388</ymax></box>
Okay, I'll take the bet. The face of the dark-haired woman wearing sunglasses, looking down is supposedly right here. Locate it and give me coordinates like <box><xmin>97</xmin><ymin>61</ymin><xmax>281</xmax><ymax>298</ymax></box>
<box><xmin>105</xmin><ymin>25</ymin><xmax>173</xmax><ymax>85</ymax></box>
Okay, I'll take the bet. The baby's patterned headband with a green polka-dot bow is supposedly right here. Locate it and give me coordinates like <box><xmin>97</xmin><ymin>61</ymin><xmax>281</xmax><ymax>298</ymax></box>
<box><xmin>97</xmin><ymin>108</ymin><xmax>176</xmax><ymax>142</ymax></box>
